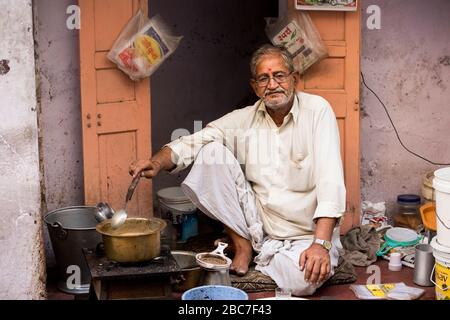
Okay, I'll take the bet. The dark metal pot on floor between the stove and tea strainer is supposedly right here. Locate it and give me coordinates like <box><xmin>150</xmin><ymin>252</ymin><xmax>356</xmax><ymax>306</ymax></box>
<box><xmin>172</xmin><ymin>250</ymin><xmax>202</xmax><ymax>292</ymax></box>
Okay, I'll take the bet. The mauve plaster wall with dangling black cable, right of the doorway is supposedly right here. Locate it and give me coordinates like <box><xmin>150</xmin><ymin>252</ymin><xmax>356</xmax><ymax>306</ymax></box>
<box><xmin>361</xmin><ymin>0</ymin><xmax>450</xmax><ymax>218</ymax></box>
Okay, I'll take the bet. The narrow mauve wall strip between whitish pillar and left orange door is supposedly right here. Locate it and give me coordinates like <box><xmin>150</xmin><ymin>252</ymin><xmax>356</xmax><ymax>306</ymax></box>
<box><xmin>34</xmin><ymin>0</ymin><xmax>84</xmax><ymax>266</ymax></box>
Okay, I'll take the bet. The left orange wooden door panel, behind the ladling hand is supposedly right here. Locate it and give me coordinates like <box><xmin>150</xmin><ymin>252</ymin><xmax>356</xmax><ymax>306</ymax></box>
<box><xmin>79</xmin><ymin>0</ymin><xmax>153</xmax><ymax>217</ymax></box>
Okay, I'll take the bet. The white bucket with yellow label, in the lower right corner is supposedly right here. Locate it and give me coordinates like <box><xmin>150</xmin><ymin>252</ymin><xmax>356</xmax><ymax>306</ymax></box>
<box><xmin>430</xmin><ymin>237</ymin><xmax>450</xmax><ymax>300</ymax></box>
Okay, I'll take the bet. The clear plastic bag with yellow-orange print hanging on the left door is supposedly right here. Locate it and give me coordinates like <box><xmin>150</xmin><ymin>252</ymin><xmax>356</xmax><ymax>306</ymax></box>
<box><xmin>107</xmin><ymin>10</ymin><xmax>182</xmax><ymax>81</ymax></box>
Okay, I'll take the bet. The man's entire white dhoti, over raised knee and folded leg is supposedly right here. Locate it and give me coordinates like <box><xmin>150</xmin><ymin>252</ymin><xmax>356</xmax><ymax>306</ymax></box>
<box><xmin>181</xmin><ymin>142</ymin><xmax>341</xmax><ymax>296</ymax></box>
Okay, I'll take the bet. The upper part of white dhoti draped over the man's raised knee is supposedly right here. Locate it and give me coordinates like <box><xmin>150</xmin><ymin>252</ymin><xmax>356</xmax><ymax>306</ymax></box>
<box><xmin>181</xmin><ymin>142</ymin><xmax>263</xmax><ymax>252</ymax></box>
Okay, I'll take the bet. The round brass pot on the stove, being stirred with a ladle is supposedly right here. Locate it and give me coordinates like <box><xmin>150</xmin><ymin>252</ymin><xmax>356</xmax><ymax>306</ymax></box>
<box><xmin>96</xmin><ymin>218</ymin><xmax>167</xmax><ymax>263</ymax></box>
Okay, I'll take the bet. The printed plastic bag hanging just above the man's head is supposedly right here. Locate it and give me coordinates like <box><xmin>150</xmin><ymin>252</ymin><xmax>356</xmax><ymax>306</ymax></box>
<box><xmin>266</xmin><ymin>10</ymin><xmax>328</xmax><ymax>74</ymax></box>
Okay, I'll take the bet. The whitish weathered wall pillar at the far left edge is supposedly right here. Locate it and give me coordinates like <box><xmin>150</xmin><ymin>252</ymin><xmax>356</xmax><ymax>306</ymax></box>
<box><xmin>0</xmin><ymin>0</ymin><xmax>46</xmax><ymax>300</ymax></box>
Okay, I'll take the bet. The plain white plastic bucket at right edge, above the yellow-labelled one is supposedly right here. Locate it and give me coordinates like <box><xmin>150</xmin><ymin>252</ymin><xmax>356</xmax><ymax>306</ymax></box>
<box><xmin>433</xmin><ymin>168</ymin><xmax>450</xmax><ymax>248</ymax></box>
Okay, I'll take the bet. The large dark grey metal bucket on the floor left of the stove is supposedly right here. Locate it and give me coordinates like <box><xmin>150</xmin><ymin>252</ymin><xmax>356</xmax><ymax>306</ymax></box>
<box><xmin>44</xmin><ymin>206</ymin><xmax>101</xmax><ymax>294</ymax></box>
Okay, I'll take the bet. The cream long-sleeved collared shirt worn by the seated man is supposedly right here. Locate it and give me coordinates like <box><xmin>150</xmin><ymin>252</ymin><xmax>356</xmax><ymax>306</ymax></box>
<box><xmin>167</xmin><ymin>92</ymin><xmax>346</xmax><ymax>240</ymax></box>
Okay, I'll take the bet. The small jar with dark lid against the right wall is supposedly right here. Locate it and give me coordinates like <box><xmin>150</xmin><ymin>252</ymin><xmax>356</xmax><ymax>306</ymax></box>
<box><xmin>394</xmin><ymin>194</ymin><xmax>422</xmax><ymax>230</ymax></box>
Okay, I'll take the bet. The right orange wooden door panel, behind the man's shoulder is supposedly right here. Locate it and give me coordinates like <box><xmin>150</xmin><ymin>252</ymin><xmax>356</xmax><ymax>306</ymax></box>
<box><xmin>298</xmin><ymin>7</ymin><xmax>361</xmax><ymax>233</ymax></box>
